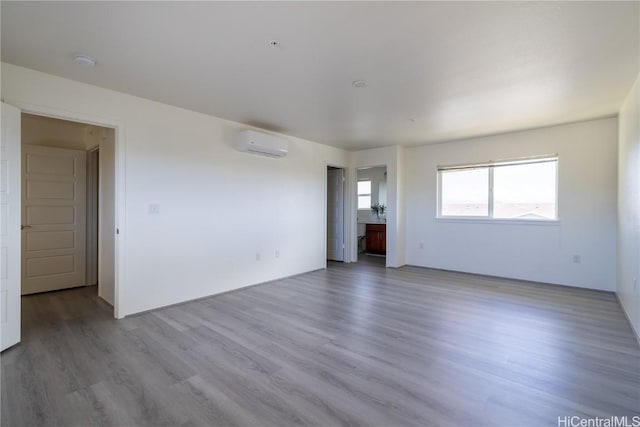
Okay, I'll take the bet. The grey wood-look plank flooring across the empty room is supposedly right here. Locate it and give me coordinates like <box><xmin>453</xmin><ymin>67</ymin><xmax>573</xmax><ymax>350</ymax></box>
<box><xmin>1</xmin><ymin>259</ymin><xmax>640</xmax><ymax>427</ymax></box>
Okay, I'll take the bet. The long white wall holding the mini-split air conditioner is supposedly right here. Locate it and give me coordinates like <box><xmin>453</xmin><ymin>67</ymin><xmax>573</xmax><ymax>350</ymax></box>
<box><xmin>2</xmin><ymin>63</ymin><xmax>348</xmax><ymax>316</ymax></box>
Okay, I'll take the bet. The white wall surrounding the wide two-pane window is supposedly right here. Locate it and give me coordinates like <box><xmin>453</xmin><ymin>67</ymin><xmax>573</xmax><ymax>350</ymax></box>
<box><xmin>405</xmin><ymin>118</ymin><xmax>617</xmax><ymax>291</ymax></box>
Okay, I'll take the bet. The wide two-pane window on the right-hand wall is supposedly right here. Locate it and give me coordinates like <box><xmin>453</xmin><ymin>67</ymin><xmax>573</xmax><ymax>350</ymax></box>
<box><xmin>438</xmin><ymin>156</ymin><xmax>558</xmax><ymax>220</ymax></box>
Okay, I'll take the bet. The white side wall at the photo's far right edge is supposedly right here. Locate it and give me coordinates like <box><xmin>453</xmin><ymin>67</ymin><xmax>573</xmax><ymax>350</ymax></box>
<box><xmin>616</xmin><ymin>75</ymin><xmax>640</xmax><ymax>342</ymax></box>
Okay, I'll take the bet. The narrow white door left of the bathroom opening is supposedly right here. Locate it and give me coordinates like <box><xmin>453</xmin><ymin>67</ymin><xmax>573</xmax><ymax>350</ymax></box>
<box><xmin>327</xmin><ymin>169</ymin><xmax>344</xmax><ymax>261</ymax></box>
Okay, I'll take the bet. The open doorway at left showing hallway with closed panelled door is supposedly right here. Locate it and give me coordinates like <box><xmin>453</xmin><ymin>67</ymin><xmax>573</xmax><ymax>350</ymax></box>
<box><xmin>21</xmin><ymin>113</ymin><xmax>115</xmax><ymax>306</ymax></box>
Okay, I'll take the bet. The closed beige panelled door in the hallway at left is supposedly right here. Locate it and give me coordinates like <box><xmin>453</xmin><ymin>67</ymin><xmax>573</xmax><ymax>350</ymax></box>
<box><xmin>22</xmin><ymin>145</ymin><xmax>86</xmax><ymax>295</ymax></box>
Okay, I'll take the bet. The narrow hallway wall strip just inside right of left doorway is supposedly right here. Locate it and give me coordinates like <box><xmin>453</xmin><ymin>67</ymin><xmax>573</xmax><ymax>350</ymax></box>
<box><xmin>98</xmin><ymin>129</ymin><xmax>116</xmax><ymax>305</ymax></box>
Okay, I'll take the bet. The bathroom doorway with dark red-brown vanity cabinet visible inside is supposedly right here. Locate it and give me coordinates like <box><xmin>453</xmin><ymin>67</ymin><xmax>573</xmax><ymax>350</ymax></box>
<box><xmin>356</xmin><ymin>165</ymin><xmax>387</xmax><ymax>261</ymax></box>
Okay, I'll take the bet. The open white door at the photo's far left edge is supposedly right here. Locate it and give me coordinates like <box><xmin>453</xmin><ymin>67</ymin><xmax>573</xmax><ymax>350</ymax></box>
<box><xmin>0</xmin><ymin>102</ymin><xmax>20</xmax><ymax>351</ymax></box>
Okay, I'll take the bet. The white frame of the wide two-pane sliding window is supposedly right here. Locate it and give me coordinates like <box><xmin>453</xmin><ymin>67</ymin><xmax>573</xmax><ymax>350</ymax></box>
<box><xmin>436</xmin><ymin>154</ymin><xmax>560</xmax><ymax>224</ymax></box>
